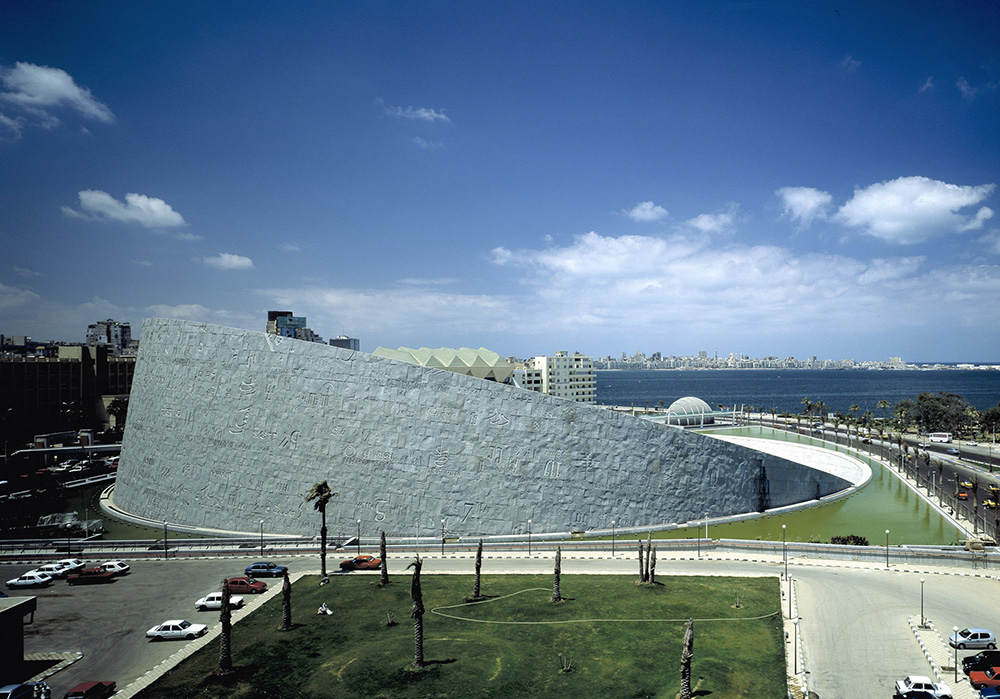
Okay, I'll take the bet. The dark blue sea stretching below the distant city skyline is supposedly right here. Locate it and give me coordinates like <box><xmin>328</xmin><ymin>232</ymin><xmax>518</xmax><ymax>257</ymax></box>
<box><xmin>595</xmin><ymin>369</ymin><xmax>1000</xmax><ymax>416</ymax></box>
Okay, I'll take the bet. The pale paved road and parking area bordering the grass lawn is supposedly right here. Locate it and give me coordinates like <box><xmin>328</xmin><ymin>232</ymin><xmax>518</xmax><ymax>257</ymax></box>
<box><xmin>0</xmin><ymin>551</ymin><xmax>1000</xmax><ymax>699</ymax></box>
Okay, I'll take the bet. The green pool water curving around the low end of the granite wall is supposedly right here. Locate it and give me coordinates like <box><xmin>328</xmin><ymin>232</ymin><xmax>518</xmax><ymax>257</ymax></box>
<box><xmin>654</xmin><ymin>427</ymin><xmax>960</xmax><ymax>546</ymax></box>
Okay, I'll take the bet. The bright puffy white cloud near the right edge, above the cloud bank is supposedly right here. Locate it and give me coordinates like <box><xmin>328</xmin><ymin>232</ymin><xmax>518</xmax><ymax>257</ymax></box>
<box><xmin>836</xmin><ymin>177</ymin><xmax>996</xmax><ymax>245</ymax></box>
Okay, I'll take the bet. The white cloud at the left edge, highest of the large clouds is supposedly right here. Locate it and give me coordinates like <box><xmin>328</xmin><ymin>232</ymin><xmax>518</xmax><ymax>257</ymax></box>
<box><xmin>0</xmin><ymin>62</ymin><xmax>115</xmax><ymax>129</ymax></box>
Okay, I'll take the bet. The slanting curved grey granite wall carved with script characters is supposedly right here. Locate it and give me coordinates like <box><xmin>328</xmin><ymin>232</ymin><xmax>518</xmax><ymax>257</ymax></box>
<box><xmin>114</xmin><ymin>319</ymin><xmax>849</xmax><ymax>536</ymax></box>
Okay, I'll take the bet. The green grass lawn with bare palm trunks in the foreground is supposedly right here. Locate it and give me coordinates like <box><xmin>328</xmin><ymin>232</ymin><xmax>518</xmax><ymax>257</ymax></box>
<box><xmin>139</xmin><ymin>576</ymin><xmax>786</xmax><ymax>699</ymax></box>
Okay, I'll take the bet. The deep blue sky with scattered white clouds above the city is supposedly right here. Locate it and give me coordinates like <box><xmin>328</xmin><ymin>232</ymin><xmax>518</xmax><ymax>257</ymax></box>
<box><xmin>0</xmin><ymin>5</ymin><xmax>1000</xmax><ymax>362</ymax></box>
